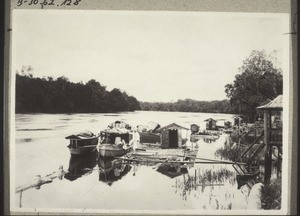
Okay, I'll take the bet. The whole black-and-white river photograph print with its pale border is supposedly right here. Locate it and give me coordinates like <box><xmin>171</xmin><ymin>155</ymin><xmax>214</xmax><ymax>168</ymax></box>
<box><xmin>9</xmin><ymin>0</ymin><xmax>294</xmax><ymax>215</ymax></box>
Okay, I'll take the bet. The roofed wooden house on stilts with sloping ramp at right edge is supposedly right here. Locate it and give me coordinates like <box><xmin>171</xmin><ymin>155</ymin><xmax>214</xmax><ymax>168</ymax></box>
<box><xmin>233</xmin><ymin>95</ymin><xmax>283</xmax><ymax>187</ymax></box>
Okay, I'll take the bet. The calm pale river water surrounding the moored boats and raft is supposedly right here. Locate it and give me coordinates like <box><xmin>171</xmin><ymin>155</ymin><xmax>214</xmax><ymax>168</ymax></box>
<box><xmin>14</xmin><ymin>111</ymin><xmax>250</xmax><ymax>211</ymax></box>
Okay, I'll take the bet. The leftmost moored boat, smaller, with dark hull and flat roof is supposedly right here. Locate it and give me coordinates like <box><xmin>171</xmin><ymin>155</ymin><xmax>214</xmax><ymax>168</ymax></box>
<box><xmin>65</xmin><ymin>131</ymin><xmax>99</xmax><ymax>155</ymax></box>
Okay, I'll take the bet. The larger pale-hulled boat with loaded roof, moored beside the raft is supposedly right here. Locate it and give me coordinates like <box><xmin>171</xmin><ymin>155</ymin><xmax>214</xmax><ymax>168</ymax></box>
<box><xmin>96</xmin><ymin>121</ymin><xmax>133</xmax><ymax>157</ymax></box>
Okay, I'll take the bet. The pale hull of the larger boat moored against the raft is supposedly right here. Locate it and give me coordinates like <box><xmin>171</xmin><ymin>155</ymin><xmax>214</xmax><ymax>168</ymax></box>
<box><xmin>97</xmin><ymin>144</ymin><xmax>132</xmax><ymax>157</ymax></box>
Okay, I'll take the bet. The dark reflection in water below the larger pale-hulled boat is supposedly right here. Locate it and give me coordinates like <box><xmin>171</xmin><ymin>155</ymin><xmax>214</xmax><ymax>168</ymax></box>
<box><xmin>98</xmin><ymin>157</ymin><xmax>132</xmax><ymax>186</ymax></box>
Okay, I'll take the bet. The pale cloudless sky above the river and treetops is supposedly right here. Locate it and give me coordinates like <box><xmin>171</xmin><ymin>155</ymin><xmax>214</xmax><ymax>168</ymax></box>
<box><xmin>12</xmin><ymin>10</ymin><xmax>289</xmax><ymax>102</ymax></box>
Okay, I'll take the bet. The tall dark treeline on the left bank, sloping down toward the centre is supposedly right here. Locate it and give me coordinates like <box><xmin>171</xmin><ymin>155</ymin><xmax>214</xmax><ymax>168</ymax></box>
<box><xmin>16</xmin><ymin>73</ymin><xmax>141</xmax><ymax>113</ymax></box>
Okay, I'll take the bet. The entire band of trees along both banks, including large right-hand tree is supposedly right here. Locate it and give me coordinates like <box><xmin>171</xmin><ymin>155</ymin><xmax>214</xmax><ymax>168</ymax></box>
<box><xmin>16</xmin><ymin>50</ymin><xmax>282</xmax><ymax>122</ymax></box>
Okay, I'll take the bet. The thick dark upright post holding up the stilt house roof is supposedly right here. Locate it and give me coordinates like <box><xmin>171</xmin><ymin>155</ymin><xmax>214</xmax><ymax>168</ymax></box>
<box><xmin>264</xmin><ymin>110</ymin><xmax>272</xmax><ymax>183</ymax></box>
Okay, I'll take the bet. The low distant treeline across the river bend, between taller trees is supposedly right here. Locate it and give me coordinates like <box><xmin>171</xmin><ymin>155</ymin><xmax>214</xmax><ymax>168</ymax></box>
<box><xmin>140</xmin><ymin>99</ymin><xmax>236</xmax><ymax>113</ymax></box>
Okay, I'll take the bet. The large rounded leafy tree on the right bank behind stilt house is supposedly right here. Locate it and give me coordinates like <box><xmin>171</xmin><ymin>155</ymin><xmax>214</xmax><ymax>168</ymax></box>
<box><xmin>225</xmin><ymin>50</ymin><xmax>283</xmax><ymax>121</ymax></box>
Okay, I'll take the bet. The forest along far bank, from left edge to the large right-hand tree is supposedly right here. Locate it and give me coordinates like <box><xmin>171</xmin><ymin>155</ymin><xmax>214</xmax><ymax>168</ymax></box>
<box><xmin>16</xmin><ymin>71</ymin><xmax>236</xmax><ymax>113</ymax></box>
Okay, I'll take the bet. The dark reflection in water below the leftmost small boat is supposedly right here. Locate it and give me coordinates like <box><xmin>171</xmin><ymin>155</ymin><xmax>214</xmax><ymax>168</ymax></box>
<box><xmin>65</xmin><ymin>152</ymin><xmax>97</xmax><ymax>181</ymax></box>
